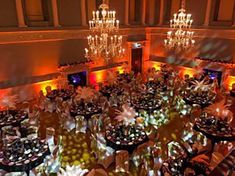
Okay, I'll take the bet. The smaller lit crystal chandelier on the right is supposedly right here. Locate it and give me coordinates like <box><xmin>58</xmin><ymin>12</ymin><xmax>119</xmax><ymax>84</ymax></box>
<box><xmin>164</xmin><ymin>0</ymin><xmax>195</xmax><ymax>49</ymax></box>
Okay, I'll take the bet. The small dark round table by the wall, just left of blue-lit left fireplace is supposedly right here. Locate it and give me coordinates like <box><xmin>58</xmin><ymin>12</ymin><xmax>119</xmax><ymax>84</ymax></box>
<box><xmin>46</xmin><ymin>89</ymin><xmax>74</xmax><ymax>101</ymax></box>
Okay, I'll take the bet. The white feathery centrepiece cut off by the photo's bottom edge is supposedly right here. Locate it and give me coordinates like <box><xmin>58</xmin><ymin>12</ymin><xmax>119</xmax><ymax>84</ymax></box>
<box><xmin>58</xmin><ymin>166</ymin><xmax>89</xmax><ymax>176</ymax></box>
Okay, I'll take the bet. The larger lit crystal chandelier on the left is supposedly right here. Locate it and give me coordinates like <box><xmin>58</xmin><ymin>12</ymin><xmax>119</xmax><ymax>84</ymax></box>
<box><xmin>85</xmin><ymin>0</ymin><xmax>125</xmax><ymax>61</ymax></box>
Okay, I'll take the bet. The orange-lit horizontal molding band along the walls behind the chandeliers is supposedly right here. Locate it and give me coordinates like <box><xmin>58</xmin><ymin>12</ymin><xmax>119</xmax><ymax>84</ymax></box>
<box><xmin>0</xmin><ymin>27</ymin><xmax>235</xmax><ymax>44</ymax></box>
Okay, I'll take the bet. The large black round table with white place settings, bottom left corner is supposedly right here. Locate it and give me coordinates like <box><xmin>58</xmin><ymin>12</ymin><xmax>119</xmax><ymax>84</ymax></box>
<box><xmin>0</xmin><ymin>138</ymin><xmax>50</xmax><ymax>175</ymax></box>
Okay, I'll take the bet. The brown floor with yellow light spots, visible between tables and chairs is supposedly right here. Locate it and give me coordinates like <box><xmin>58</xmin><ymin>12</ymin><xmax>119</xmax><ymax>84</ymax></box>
<box><xmin>35</xmin><ymin>95</ymin><xmax>235</xmax><ymax>176</ymax></box>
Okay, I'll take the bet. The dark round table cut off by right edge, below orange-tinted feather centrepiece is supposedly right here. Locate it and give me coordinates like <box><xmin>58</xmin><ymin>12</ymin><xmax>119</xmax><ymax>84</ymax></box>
<box><xmin>193</xmin><ymin>114</ymin><xmax>235</xmax><ymax>152</ymax></box>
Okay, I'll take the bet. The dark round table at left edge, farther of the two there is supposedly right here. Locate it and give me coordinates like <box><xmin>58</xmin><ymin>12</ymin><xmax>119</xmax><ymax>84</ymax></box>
<box><xmin>0</xmin><ymin>110</ymin><xmax>28</xmax><ymax>129</ymax></box>
